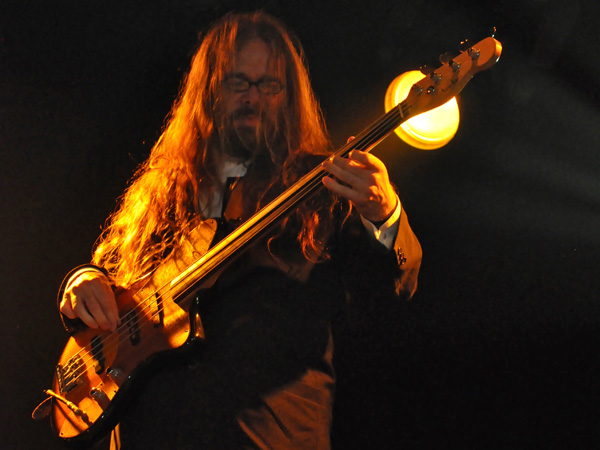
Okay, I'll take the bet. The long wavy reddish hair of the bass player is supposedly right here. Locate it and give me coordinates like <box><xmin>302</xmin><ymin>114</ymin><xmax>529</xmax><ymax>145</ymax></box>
<box><xmin>93</xmin><ymin>12</ymin><xmax>336</xmax><ymax>286</ymax></box>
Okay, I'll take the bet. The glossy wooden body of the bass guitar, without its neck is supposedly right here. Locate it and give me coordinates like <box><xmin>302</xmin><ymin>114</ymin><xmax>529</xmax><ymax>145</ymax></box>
<box><xmin>51</xmin><ymin>220</ymin><xmax>216</xmax><ymax>447</ymax></box>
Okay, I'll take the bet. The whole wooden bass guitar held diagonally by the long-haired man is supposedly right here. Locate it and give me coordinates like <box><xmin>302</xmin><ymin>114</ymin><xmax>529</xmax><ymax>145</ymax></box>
<box><xmin>33</xmin><ymin>37</ymin><xmax>502</xmax><ymax>447</ymax></box>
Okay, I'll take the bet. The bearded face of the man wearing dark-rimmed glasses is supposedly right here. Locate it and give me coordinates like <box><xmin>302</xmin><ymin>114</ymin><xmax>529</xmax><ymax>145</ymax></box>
<box><xmin>222</xmin><ymin>39</ymin><xmax>285</xmax><ymax>157</ymax></box>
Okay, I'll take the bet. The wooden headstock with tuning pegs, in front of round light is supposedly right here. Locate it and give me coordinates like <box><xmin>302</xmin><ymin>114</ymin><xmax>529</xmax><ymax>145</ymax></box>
<box><xmin>401</xmin><ymin>37</ymin><xmax>502</xmax><ymax>119</ymax></box>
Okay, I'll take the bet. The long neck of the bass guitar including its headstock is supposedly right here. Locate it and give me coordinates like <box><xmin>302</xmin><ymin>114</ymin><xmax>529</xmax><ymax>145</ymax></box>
<box><xmin>148</xmin><ymin>37</ymin><xmax>502</xmax><ymax>302</ymax></box>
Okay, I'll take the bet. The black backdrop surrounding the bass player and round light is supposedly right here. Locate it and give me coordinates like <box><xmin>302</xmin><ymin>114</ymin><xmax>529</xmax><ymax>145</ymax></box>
<box><xmin>0</xmin><ymin>0</ymin><xmax>600</xmax><ymax>449</ymax></box>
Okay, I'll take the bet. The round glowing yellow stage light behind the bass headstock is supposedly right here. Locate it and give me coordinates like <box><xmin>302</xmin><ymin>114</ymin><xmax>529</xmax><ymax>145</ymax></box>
<box><xmin>385</xmin><ymin>70</ymin><xmax>460</xmax><ymax>150</ymax></box>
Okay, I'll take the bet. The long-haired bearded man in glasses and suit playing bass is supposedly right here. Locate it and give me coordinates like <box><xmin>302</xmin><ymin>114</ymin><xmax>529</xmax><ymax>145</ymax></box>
<box><xmin>59</xmin><ymin>12</ymin><xmax>421</xmax><ymax>449</ymax></box>
